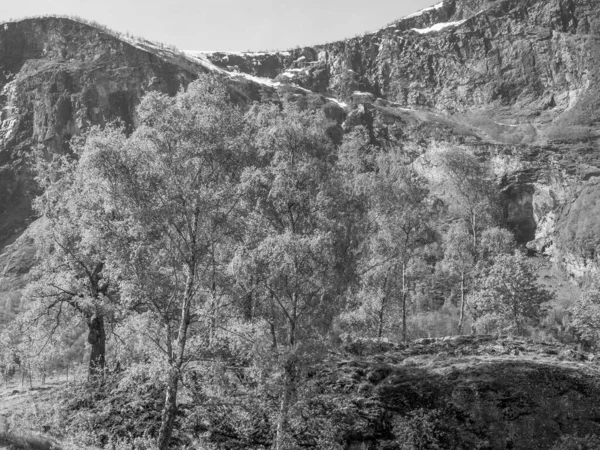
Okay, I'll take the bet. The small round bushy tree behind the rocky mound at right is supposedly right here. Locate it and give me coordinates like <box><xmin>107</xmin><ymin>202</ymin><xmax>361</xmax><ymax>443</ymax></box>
<box><xmin>468</xmin><ymin>254</ymin><xmax>553</xmax><ymax>335</ymax></box>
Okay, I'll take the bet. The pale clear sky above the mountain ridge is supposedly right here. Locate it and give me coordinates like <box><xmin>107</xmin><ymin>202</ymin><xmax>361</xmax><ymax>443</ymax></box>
<box><xmin>0</xmin><ymin>0</ymin><xmax>440</xmax><ymax>51</ymax></box>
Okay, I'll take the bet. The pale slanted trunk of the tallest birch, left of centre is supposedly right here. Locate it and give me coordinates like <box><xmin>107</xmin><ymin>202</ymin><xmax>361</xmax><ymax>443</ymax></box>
<box><xmin>157</xmin><ymin>261</ymin><xmax>196</xmax><ymax>450</ymax></box>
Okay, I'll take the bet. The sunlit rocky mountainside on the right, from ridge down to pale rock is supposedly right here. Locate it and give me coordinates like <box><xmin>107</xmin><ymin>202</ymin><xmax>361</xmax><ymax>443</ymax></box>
<box><xmin>202</xmin><ymin>0</ymin><xmax>600</xmax><ymax>277</ymax></box>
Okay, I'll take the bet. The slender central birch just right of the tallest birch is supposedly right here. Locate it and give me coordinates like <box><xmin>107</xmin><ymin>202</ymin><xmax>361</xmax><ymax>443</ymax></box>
<box><xmin>235</xmin><ymin>104</ymin><xmax>344</xmax><ymax>450</ymax></box>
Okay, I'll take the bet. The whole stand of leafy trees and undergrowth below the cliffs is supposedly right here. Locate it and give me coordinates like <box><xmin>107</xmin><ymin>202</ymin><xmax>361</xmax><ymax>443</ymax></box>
<box><xmin>0</xmin><ymin>77</ymin><xmax>597</xmax><ymax>450</ymax></box>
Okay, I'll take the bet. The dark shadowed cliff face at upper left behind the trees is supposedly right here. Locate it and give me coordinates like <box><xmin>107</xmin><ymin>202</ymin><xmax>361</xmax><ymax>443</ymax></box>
<box><xmin>0</xmin><ymin>18</ymin><xmax>202</xmax><ymax>250</ymax></box>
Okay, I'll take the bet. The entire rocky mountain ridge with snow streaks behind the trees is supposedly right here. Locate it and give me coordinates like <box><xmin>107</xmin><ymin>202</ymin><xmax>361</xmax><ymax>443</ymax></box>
<box><xmin>0</xmin><ymin>0</ymin><xmax>600</xmax><ymax>320</ymax></box>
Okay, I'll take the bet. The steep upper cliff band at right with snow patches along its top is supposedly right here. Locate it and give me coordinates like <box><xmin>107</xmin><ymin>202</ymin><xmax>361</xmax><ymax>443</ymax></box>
<box><xmin>207</xmin><ymin>0</ymin><xmax>600</xmax><ymax>123</ymax></box>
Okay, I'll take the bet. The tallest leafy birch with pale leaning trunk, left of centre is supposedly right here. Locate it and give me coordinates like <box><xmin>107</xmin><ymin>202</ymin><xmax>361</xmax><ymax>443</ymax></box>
<box><xmin>42</xmin><ymin>77</ymin><xmax>244</xmax><ymax>449</ymax></box>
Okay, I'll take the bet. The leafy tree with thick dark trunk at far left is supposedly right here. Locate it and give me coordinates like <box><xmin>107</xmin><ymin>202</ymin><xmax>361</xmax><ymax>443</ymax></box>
<box><xmin>27</xmin><ymin>140</ymin><xmax>122</xmax><ymax>377</ymax></box>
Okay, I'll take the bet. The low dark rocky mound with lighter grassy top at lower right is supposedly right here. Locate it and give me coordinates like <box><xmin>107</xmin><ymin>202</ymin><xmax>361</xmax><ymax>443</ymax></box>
<box><xmin>330</xmin><ymin>336</ymin><xmax>600</xmax><ymax>450</ymax></box>
